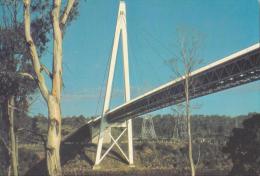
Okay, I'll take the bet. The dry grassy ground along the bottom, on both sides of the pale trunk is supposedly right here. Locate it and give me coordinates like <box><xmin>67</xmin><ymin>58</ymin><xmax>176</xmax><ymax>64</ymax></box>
<box><xmin>17</xmin><ymin>137</ymin><xmax>231</xmax><ymax>176</ymax></box>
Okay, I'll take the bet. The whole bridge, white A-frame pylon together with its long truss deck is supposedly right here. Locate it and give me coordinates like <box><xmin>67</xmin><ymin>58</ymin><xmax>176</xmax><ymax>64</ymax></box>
<box><xmin>60</xmin><ymin>1</ymin><xmax>260</xmax><ymax>169</ymax></box>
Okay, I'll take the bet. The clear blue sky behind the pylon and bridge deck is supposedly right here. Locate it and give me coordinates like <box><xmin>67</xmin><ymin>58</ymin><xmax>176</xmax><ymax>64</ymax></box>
<box><xmin>30</xmin><ymin>0</ymin><xmax>260</xmax><ymax>116</ymax></box>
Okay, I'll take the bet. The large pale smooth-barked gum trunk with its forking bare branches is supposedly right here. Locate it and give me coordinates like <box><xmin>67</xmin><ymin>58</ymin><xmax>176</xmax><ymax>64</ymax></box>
<box><xmin>23</xmin><ymin>0</ymin><xmax>77</xmax><ymax>176</ymax></box>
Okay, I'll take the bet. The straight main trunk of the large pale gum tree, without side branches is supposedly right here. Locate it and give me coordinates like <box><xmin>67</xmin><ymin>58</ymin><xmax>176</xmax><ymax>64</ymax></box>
<box><xmin>47</xmin><ymin>0</ymin><xmax>62</xmax><ymax>176</ymax></box>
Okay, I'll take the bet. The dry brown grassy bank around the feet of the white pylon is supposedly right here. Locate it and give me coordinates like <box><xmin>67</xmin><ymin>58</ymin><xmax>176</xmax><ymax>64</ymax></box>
<box><xmin>60</xmin><ymin>143</ymin><xmax>229</xmax><ymax>176</ymax></box>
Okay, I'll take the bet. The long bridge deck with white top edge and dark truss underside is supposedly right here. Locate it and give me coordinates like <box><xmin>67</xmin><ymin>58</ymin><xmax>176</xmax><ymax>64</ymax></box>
<box><xmin>104</xmin><ymin>43</ymin><xmax>260</xmax><ymax>122</ymax></box>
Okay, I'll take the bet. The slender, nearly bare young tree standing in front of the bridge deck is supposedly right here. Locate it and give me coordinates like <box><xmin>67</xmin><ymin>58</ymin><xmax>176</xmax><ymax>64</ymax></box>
<box><xmin>168</xmin><ymin>29</ymin><xmax>202</xmax><ymax>176</ymax></box>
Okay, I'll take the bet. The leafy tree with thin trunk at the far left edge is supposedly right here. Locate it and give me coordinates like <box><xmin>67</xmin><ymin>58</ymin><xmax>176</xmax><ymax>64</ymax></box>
<box><xmin>0</xmin><ymin>0</ymin><xmax>48</xmax><ymax>176</ymax></box>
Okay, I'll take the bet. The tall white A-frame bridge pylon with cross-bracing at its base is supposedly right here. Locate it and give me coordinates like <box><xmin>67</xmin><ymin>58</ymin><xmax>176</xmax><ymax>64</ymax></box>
<box><xmin>94</xmin><ymin>1</ymin><xmax>133</xmax><ymax>169</ymax></box>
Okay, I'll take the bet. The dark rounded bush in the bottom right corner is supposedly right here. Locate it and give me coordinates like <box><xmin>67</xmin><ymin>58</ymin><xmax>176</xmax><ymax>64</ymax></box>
<box><xmin>223</xmin><ymin>114</ymin><xmax>260</xmax><ymax>176</ymax></box>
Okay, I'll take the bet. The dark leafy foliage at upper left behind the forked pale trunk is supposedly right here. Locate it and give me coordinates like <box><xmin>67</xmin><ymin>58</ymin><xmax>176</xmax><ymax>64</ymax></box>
<box><xmin>0</xmin><ymin>0</ymin><xmax>79</xmax><ymax>100</ymax></box>
